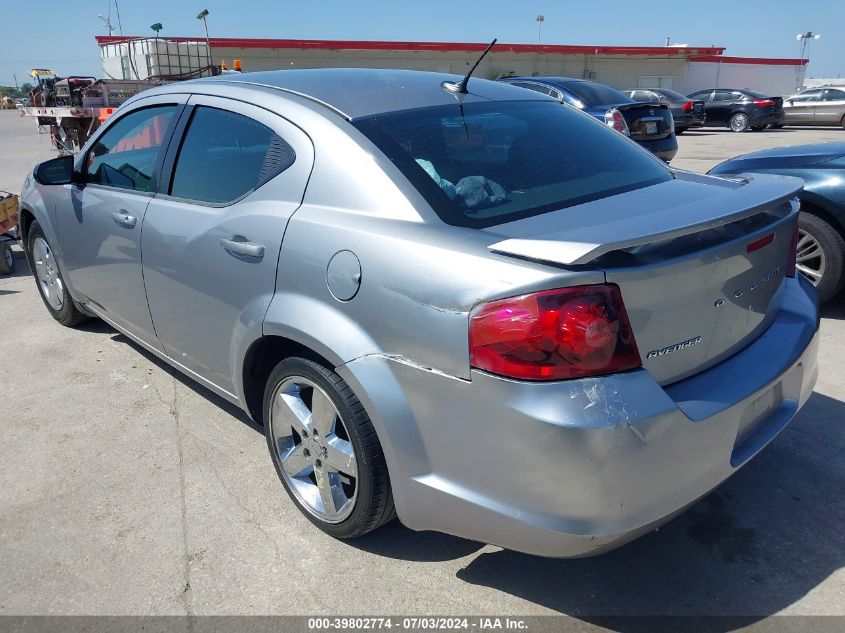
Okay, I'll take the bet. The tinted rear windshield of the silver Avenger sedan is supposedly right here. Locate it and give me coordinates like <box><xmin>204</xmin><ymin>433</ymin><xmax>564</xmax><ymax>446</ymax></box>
<box><xmin>353</xmin><ymin>101</ymin><xmax>672</xmax><ymax>228</ymax></box>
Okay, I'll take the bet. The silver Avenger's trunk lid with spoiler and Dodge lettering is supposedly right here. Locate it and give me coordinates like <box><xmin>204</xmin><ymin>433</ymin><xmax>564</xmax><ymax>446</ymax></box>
<box><xmin>489</xmin><ymin>174</ymin><xmax>801</xmax><ymax>384</ymax></box>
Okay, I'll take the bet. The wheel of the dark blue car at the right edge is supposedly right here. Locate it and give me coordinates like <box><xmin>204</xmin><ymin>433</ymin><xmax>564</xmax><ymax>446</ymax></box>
<box><xmin>796</xmin><ymin>211</ymin><xmax>845</xmax><ymax>303</ymax></box>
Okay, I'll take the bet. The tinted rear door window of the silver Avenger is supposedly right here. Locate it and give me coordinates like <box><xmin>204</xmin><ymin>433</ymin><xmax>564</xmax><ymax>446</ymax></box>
<box><xmin>170</xmin><ymin>106</ymin><xmax>296</xmax><ymax>204</ymax></box>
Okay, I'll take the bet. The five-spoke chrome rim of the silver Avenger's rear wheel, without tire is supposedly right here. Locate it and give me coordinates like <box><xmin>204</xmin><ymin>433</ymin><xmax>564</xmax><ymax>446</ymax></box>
<box><xmin>269</xmin><ymin>376</ymin><xmax>358</xmax><ymax>523</ymax></box>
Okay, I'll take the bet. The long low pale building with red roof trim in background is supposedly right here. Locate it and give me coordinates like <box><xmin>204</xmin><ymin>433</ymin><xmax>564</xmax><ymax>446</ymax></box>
<box><xmin>97</xmin><ymin>36</ymin><xmax>808</xmax><ymax>95</ymax></box>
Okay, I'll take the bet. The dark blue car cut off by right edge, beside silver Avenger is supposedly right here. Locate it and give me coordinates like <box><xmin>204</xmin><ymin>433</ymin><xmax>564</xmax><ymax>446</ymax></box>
<box><xmin>709</xmin><ymin>142</ymin><xmax>845</xmax><ymax>302</ymax></box>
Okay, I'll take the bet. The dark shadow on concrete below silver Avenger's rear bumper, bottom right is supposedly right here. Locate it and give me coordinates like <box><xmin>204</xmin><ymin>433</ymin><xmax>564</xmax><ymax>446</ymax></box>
<box><xmin>457</xmin><ymin>393</ymin><xmax>845</xmax><ymax>631</ymax></box>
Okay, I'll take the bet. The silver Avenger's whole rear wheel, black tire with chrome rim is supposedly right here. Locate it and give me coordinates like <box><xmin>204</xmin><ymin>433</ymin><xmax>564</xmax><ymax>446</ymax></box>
<box><xmin>264</xmin><ymin>357</ymin><xmax>395</xmax><ymax>539</ymax></box>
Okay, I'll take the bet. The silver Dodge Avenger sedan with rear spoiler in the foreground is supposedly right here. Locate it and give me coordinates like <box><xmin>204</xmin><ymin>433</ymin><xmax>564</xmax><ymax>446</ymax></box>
<box><xmin>21</xmin><ymin>69</ymin><xmax>819</xmax><ymax>556</ymax></box>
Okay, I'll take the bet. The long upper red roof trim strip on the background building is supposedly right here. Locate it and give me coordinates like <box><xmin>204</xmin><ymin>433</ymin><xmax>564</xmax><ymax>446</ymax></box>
<box><xmin>95</xmin><ymin>35</ymin><xmax>725</xmax><ymax>57</ymax></box>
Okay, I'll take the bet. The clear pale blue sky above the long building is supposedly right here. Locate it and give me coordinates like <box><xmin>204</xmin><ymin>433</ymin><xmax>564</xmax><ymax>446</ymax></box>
<box><xmin>0</xmin><ymin>0</ymin><xmax>845</xmax><ymax>85</ymax></box>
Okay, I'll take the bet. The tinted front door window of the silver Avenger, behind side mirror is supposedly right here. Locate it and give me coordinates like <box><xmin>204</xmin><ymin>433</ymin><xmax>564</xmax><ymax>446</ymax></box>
<box><xmin>85</xmin><ymin>105</ymin><xmax>179</xmax><ymax>192</ymax></box>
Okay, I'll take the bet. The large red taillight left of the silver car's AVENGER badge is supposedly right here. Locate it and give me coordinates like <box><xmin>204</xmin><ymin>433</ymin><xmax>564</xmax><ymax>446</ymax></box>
<box><xmin>469</xmin><ymin>285</ymin><xmax>642</xmax><ymax>380</ymax></box>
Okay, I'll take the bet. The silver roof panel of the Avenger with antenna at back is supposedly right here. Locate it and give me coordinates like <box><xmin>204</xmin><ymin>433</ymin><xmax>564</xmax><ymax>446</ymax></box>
<box><xmin>184</xmin><ymin>68</ymin><xmax>551</xmax><ymax>119</ymax></box>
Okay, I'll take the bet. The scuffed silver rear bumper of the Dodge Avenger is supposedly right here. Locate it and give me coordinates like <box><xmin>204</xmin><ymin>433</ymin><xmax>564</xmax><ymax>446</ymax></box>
<box><xmin>338</xmin><ymin>279</ymin><xmax>818</xmax><ymax>557</ymax></box>
